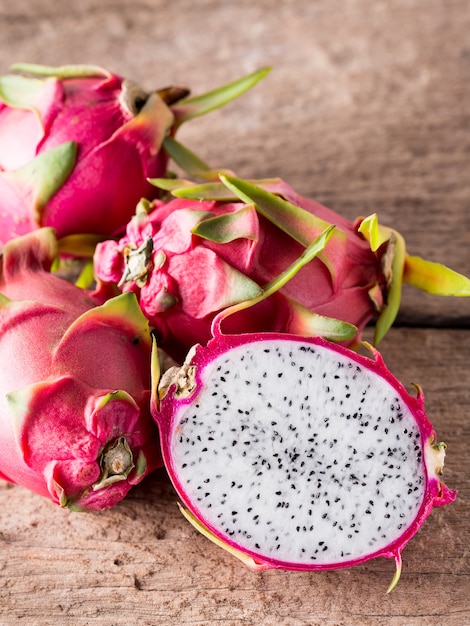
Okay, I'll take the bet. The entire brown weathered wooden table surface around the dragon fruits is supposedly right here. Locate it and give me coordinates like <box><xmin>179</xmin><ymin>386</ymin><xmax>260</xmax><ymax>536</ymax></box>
<box><xmin>0</xmin><ymin>0</ymin><xmax>470</xmax><ymax>626</ymax></box>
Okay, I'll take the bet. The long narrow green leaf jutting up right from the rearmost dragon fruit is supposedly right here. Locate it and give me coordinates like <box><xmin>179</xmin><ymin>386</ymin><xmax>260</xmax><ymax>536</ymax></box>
<box><xmin>171</xmin><ymin>68</ymin><xmax>271</xmax><ymax>127</ymax></box>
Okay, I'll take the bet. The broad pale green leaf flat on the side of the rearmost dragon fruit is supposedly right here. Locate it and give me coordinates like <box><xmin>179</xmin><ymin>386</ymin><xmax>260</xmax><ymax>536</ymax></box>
<box><xmin>4</xmin><ymin>141</ymin><xmax>77</xmax><ymax>219</ymax></box>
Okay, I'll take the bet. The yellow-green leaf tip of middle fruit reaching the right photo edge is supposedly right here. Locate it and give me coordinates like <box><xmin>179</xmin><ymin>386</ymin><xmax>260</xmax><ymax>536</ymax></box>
<box><xmin>403</xmin><ymin>255</ymin><xmax>470</xmax><ymax>296</ymax></box>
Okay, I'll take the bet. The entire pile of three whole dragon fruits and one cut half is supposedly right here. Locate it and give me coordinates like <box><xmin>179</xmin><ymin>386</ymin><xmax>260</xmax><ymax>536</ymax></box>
<box><xmin>0</xmin><ymin>64</ymin><xmax>470</xmax><ymax>589</ymax></box>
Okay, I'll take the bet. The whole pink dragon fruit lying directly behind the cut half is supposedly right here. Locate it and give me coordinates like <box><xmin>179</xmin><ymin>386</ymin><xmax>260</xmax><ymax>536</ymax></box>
<box><xmin>94</xmin><ymin>174</ymin><xmax>470</xmax><ymax>362</ymax></box>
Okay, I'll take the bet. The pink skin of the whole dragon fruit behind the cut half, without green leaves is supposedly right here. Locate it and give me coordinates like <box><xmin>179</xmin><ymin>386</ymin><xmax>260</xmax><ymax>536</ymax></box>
<box><xmin>94</xmin><ymin>179</ymin><xmax>385</xmax><ymax>359</ymax></box>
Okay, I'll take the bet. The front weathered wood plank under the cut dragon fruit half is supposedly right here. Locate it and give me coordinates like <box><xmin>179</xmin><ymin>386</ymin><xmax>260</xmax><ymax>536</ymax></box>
<box><xmin>0</xmin><ymin>329</ymin><xmax>470</xmax><ymax>626</ymax></box>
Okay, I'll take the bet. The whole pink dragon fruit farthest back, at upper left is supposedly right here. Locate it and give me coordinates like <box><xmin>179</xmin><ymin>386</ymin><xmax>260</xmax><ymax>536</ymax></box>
<box><xmin>0</xmin><ymin>64</ymin><xmax>268</xmax><ymax>244</ymax></box>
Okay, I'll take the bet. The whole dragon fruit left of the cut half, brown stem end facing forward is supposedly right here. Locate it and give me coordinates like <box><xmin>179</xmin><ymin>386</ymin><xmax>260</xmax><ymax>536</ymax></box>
<box><xmin>0</xmin><ymin>228</ymin><xmax>161</xmax><ymax>510</ymax></box>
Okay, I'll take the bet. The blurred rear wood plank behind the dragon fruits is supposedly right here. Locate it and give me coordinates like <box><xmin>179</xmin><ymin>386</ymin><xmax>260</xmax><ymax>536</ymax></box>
<box><xmin>0</xmin><ymin>0</ymin><xmax>470</xmax><ymax>327</ymax></box>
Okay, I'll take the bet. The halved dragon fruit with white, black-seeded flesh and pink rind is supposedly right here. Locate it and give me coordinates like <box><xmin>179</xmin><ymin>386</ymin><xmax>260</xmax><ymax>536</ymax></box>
<box><xmin>153</xmin><ymin>332</ymin><xmax>456</xmax><ymax>590</ymax></box>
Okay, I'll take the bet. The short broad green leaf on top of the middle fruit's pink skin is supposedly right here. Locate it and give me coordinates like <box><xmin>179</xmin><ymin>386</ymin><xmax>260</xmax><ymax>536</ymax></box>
<box><xmin>191</xmin><ymin>204</ymin><xmax>258</xmax><ymax>243</ymax></box>
